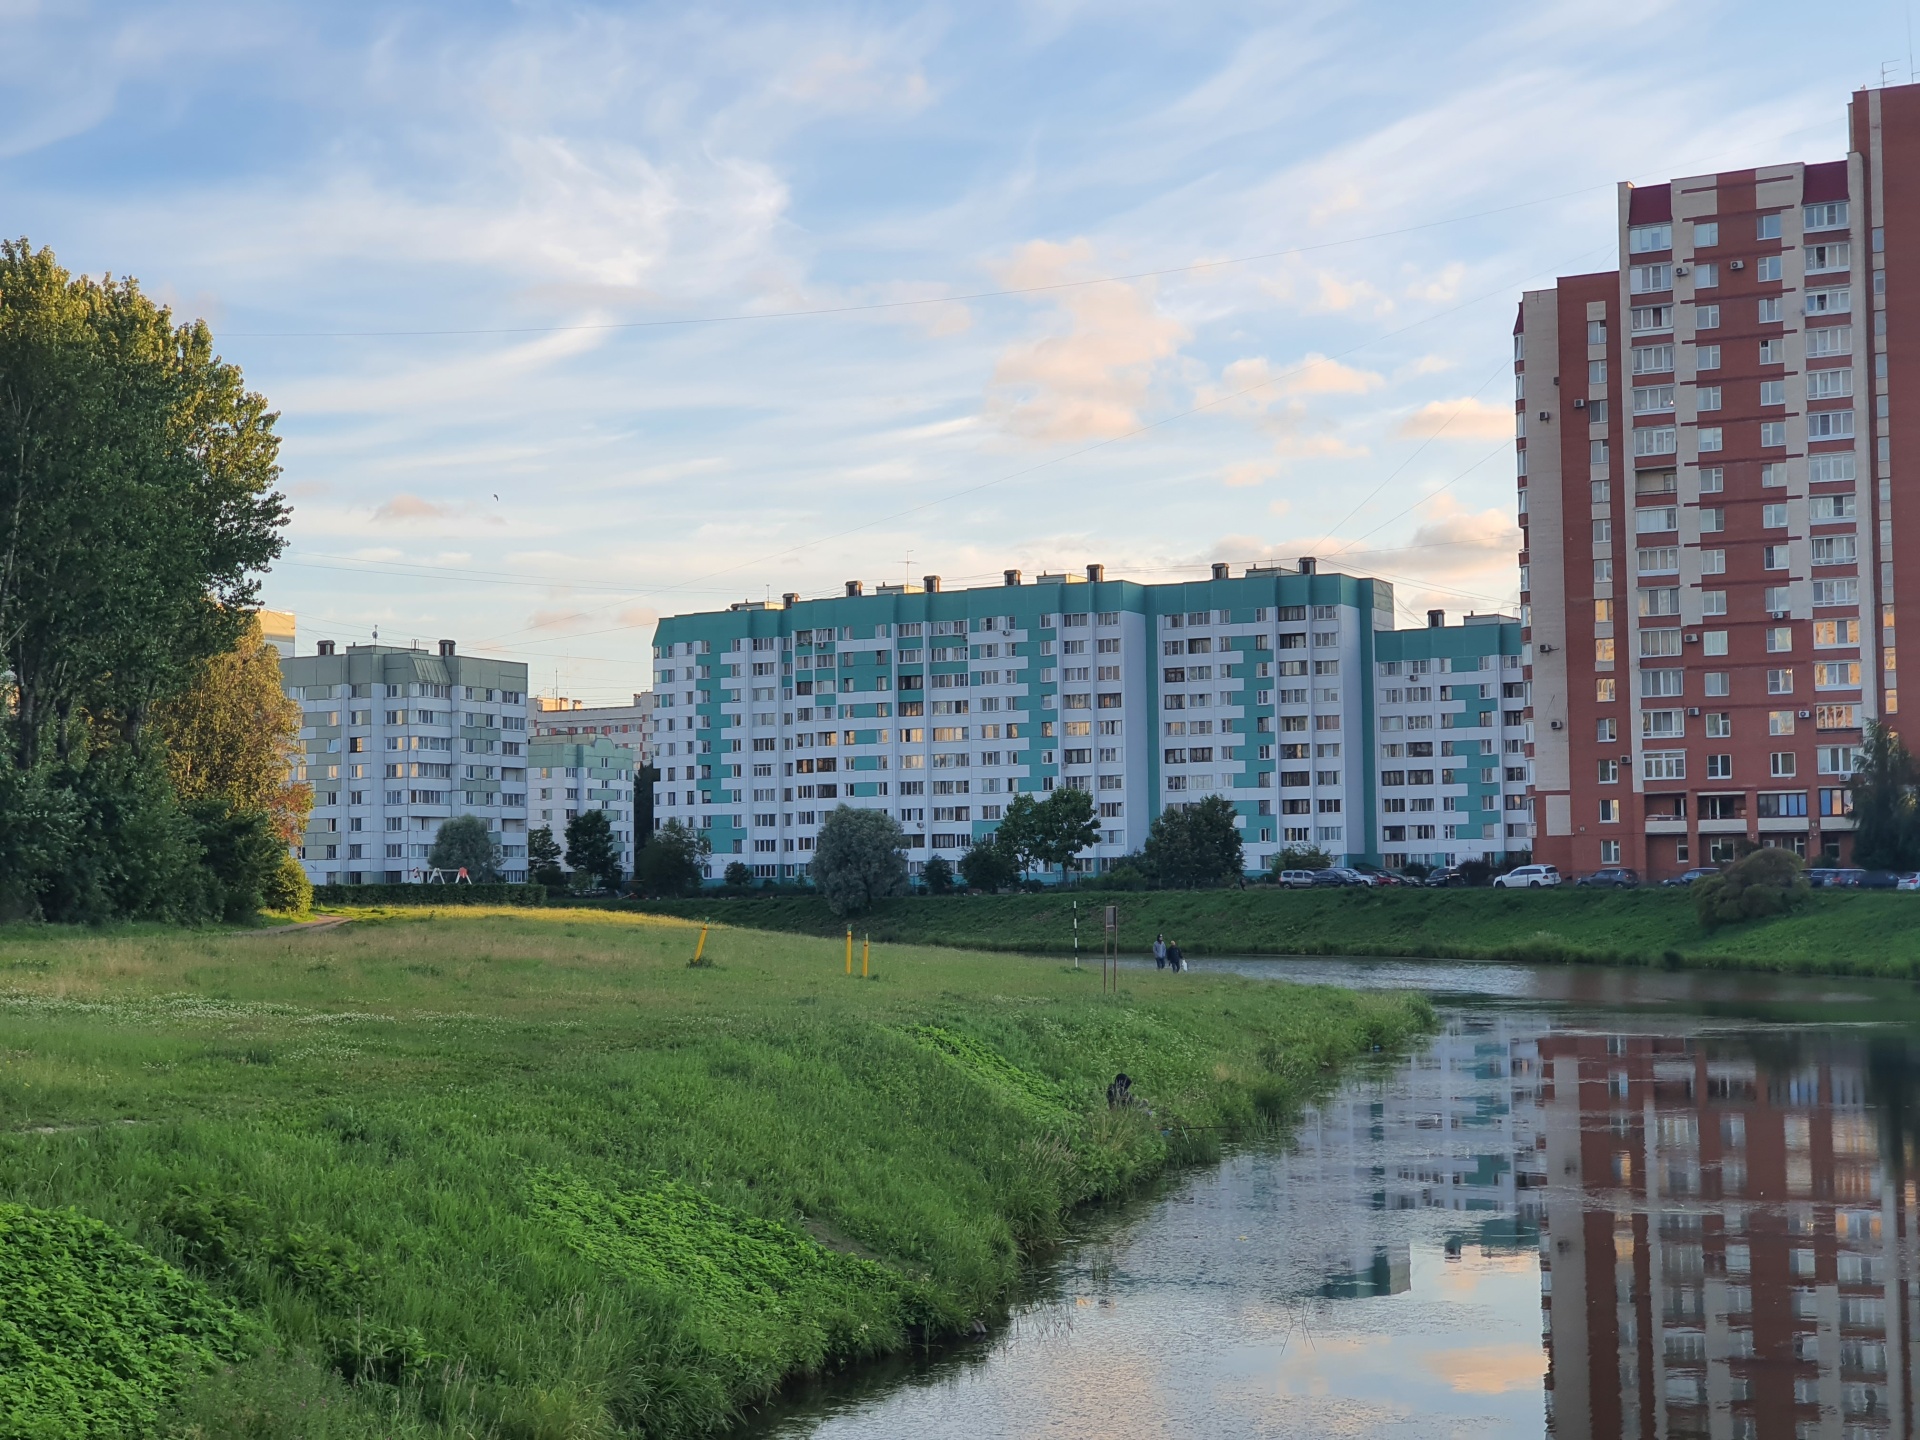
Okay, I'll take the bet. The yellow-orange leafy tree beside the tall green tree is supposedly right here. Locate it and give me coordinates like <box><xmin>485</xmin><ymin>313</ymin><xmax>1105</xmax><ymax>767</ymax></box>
<box><xmin>154</xmin><ymin>618</ymin><xmax>313</xmax><ymax>845</ymax></box>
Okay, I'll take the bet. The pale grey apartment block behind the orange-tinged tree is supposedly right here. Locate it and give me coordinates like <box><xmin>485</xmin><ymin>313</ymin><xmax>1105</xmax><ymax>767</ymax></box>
<box><xmin>280</xmin><ymin>639</ymin><xmax>528</xmax><ymax>885</ymax></box>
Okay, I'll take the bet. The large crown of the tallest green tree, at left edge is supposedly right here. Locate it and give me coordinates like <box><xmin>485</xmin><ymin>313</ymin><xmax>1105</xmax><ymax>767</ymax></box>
<box><xmin>0</xmin><ymin>240</ymin><xmax>286</xmax><ymax>770</ymax></box>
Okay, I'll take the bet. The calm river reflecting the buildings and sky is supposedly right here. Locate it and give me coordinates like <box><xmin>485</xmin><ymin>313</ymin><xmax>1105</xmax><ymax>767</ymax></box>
<box><xmin>755</xmin><ymin>958</ymin><xmax>1920</xmax><ymax>1440</ymax></box>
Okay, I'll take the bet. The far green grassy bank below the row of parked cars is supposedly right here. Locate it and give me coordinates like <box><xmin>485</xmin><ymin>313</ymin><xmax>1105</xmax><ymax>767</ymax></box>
<box><xmin>625</xmin><ymin>887</ymin><xmax>1920</xmax><ymax>975</ymax></box>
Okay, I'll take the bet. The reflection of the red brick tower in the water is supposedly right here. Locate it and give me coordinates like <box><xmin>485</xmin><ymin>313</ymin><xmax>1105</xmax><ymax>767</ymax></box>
<box><xmin>1540</xmin><ymin>1035</ymin><xmax>1916</xmax><ymax>1440</ymax></box>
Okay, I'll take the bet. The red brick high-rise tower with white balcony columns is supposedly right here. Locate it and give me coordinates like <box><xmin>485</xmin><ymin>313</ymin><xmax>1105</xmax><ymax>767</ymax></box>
<box><xmin>1513</xmin><ymin>86</ymin><xmax>1920</xmax><ymax>877</ymax></box>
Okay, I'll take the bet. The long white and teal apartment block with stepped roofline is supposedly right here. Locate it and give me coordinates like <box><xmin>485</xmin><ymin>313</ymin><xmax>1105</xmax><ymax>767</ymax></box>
<box><xmin>651</xmin><ymin>559</ymin><xmax>1519</xmax><ymax>879</ymax></box>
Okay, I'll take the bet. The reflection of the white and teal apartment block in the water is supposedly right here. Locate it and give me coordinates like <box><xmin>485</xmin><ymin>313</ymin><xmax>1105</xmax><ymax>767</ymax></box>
<box><xmin>1286</xmin><ymin>1014</ymin><xmax>1546</xmax><ymax>1298</ymax></box>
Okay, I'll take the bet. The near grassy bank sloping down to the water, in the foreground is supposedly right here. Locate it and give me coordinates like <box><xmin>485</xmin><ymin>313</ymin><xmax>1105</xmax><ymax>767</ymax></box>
<box><xmin>0</xmin><ymin>910</ymin><xmax>1428</xmax><ymax>1440</ymax></box>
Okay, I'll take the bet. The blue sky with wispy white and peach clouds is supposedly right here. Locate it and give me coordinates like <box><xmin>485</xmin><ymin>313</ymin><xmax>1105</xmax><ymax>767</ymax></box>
<box><xmin>0</xmin><ymin>0</ymin><xmax>1910</xmax><ymax>701</ymax></box>
